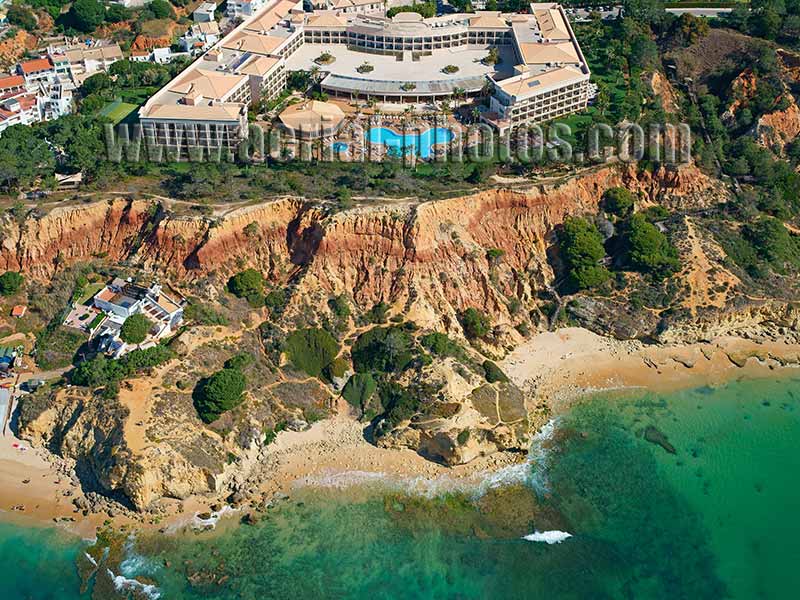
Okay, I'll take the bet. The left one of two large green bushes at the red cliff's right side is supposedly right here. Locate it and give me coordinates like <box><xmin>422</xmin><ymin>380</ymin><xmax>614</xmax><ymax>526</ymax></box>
<box><xmin>558</xmin><ymin>217</ymin><xmax>611</xmax><ymax>292</ymax></box>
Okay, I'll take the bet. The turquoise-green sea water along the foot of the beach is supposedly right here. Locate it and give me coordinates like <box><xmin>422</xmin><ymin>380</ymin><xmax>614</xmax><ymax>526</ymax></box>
<box><xmin>0</xmin><ymin>378</ymin><xmax>800</xmax><ymax>600</ymax></box>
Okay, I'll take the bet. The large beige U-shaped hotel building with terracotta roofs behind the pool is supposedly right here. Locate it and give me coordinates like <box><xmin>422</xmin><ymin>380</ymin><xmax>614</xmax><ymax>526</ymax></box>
<box><xmin>140</xmin><ymin>0</ymin><xmax>589</xmax><ymax>148</ymax></box>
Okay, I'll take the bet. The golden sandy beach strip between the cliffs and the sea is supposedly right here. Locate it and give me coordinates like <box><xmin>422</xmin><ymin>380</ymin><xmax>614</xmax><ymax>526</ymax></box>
<box><xmin>0</xmin><ymin>328</ymin><xmax>800</xmax><ymax>539</ymax></box>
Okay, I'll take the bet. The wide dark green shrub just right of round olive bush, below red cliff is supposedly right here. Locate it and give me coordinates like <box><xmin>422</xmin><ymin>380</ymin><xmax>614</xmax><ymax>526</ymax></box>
<box><xmin>351</xmin><ymin>326</ymin><xmax>414</xmax><ymax>373</ymax></box>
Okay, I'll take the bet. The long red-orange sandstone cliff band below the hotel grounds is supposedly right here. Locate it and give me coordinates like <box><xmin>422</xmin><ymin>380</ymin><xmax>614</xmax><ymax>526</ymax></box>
<box><xmin>0</xmin><ymin>167</ymin><xmax>725</xmax><ymax>326</ymax></box>
